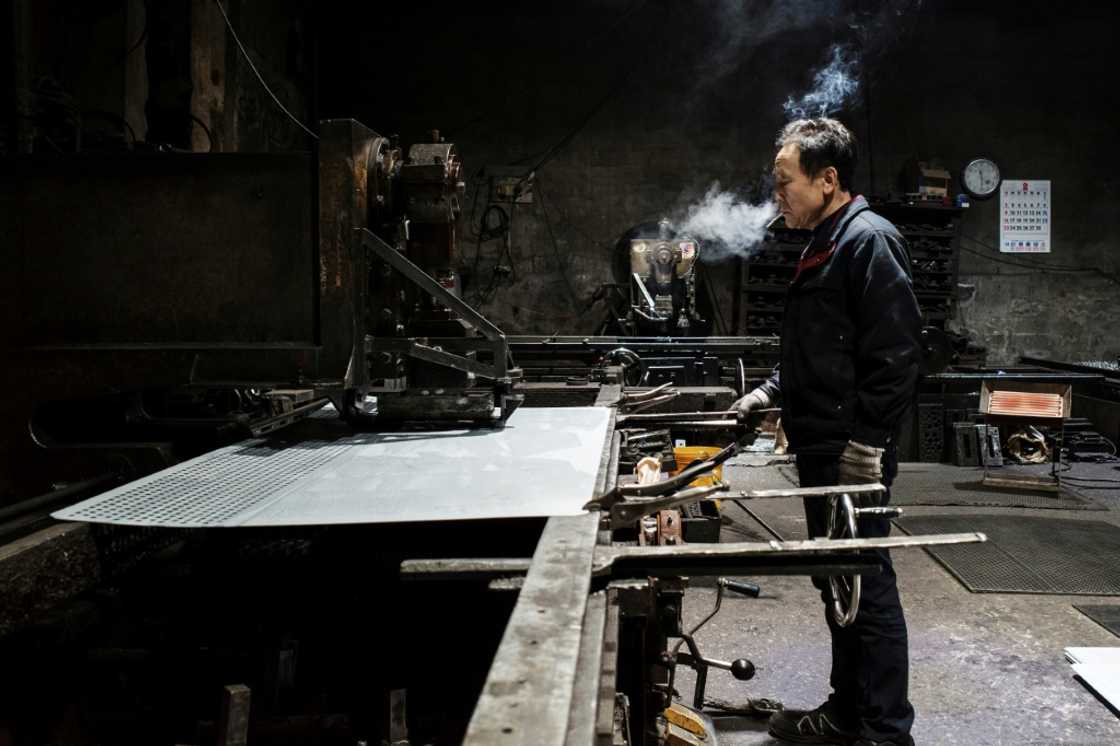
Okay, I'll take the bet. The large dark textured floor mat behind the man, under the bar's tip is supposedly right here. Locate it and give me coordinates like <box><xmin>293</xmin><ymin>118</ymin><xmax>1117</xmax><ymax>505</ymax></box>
<box><xmin>895</xmin><ymin>514</ymin><xmax>1120</xmax><ymax>596</ymax></box>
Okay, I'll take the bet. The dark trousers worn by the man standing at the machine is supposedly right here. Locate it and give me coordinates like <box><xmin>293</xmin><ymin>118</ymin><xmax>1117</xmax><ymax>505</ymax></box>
<box><xmin>797</xmin><ymin>454</ymin><xmax>914</xmax><ymax>743</ymax></box>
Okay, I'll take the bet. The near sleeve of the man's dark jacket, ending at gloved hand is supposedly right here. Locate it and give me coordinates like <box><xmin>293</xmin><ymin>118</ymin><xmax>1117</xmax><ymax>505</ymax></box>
<box><xmin>849</xmin><ymin>231</ymin><xmax>922</xmax><ymax>448</ymax></box>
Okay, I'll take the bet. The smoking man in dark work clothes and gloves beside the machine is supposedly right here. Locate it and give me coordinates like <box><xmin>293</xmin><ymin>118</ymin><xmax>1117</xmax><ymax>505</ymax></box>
<box><xmin>737</xmin><ymin>119</ymin><xmax>921</xmax><ymax>746</ymax></box>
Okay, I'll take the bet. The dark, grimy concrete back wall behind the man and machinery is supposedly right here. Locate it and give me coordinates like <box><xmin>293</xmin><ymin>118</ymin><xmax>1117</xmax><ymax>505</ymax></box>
<box><xmin>320</xmin><ymin>0</ymin><xmax>1120</xmax><ymax>362</ymax></box>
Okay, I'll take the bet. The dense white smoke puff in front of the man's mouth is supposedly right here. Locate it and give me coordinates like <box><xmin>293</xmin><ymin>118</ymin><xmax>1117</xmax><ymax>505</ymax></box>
<box><xmin>674</xmin><ymin>181</ymin><xmax>777</xmax><ymax>261</ymax></box>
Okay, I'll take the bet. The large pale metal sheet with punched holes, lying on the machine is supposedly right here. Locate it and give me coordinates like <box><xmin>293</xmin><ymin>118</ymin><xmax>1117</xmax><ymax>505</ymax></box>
<box><xmin>54</xmin><ymin>407</ymin><xmax>612</xmax><ymax>528</ymax></box>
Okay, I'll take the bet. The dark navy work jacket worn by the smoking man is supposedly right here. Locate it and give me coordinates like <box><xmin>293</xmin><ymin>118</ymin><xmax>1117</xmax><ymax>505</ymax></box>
<box><xmin>762</xmin><ymin>196</ymin><xmax>922</xmax><ymax>454</ymax></box>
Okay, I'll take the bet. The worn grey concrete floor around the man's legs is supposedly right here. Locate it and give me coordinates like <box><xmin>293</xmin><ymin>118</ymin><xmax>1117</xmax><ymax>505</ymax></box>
<box><xmin>678</xmin><ymin>459</ymin><xmax>1120</xmax><ymax>746</ymax></box>
